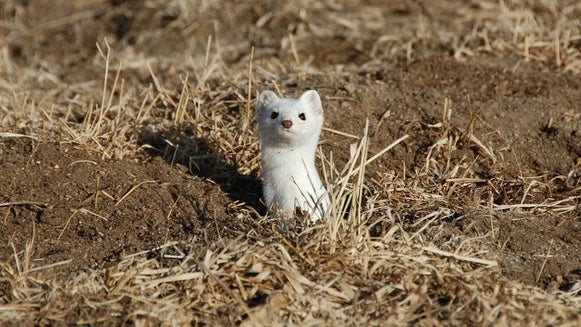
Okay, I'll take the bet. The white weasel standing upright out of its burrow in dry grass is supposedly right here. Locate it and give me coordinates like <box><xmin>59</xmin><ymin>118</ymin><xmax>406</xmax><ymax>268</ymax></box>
<box><xmin>256</xmin><ymin>90</ymin><xmax>329</xmax><ymax>221</ymax></box>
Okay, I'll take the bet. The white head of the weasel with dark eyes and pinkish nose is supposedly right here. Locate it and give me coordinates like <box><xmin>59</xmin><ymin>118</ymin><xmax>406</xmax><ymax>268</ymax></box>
<box><xmin>256</xmin><ymin>90</ymin><xmax>324</xmax><ymax>145</ymax></box>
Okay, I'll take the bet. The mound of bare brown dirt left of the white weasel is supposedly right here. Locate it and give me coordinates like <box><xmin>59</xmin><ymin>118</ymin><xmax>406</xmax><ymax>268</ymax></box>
<box><xmin>0</xmin><ymin>139</ymin><xmax>240</xmax><ymax>274</ymax></box>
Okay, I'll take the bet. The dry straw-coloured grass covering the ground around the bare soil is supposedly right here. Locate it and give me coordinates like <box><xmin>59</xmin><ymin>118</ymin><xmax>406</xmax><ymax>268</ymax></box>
<box><xmin>0</xmin><ymin>0</ymin><xmax>581</xmax><ymax>326</ymax></box>
